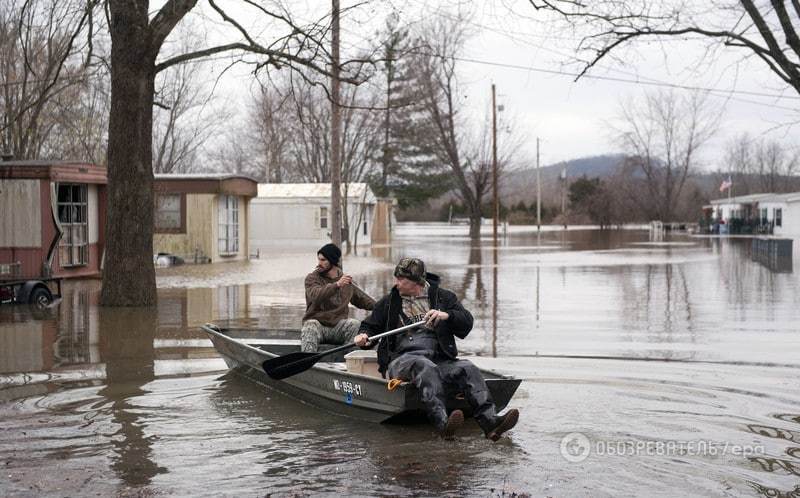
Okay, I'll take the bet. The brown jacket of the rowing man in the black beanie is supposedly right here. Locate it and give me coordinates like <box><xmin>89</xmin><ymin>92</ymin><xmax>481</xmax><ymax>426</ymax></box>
<box><xmin>303</xmin><ymin>270</ymin><xmax>375</xmax><ymax>327</ymax></box>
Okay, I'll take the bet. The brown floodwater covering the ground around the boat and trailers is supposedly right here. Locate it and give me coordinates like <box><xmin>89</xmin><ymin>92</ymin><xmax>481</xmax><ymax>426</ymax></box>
<box><xmin>0</xmin><ymin>225</ymin><xmax>800</xmax><ymax>497</ymax></box>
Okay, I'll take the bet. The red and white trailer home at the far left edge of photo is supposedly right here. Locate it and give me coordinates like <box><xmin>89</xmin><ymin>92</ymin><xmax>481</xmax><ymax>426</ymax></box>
<box><xmin>0</xmin><ymin>161</ymin><xmax>107</xmax><ymax>278</ymax></box>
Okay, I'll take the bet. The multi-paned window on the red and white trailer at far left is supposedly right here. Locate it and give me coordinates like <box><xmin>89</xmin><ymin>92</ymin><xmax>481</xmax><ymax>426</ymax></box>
<box><xmin>58</xmin><ymin>183</ymin><xmax>89</xmax><ymax>268</ymax></box>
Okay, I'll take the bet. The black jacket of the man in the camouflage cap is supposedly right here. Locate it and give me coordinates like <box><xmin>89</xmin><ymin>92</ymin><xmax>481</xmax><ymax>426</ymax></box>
<box><xmin>360</xmin><ymin>273</ymin><xmax>472</xmax><ymax>376</ymax></box>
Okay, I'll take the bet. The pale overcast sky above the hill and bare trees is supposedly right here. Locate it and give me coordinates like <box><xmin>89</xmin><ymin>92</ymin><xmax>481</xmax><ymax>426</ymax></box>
<box><xmin>178</xmin><ymin>0</ymin><xmax>800</xmax><ymax>170</ymax></box>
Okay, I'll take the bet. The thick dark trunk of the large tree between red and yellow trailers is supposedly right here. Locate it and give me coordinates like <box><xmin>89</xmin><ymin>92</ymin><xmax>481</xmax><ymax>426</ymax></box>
<box><xmin>101</xmin><ymin>2</ymin><xmax>156</xmax><ymax>306</ymax></box>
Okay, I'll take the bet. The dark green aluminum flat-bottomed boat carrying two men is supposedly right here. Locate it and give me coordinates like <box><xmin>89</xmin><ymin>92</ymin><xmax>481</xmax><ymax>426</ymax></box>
<box><xmin>202</xmin><ymin>323</ymin><xmax>521</xmax><ymax>423</ymax></box>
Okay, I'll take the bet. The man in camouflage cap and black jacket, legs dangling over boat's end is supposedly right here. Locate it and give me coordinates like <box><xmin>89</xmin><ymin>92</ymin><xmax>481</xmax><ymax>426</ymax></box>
<box><xmin>355</xmin><ymin>258</ymin><xmax>519</xmax><ymax>441</ymax></box>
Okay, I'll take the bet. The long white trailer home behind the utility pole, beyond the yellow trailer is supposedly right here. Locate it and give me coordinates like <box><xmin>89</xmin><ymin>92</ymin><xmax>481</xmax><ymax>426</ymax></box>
<box><xmin>249</xmin><ymin>183</ymin><xmax>377</xmax><ymax>254</ymax></box>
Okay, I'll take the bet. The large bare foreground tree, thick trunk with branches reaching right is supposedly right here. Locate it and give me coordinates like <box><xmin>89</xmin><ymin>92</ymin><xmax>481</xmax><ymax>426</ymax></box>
<box><xmin>102</xmin><ymin>0</ymin><xmax>362</xmax><ymax>306</ymax></box>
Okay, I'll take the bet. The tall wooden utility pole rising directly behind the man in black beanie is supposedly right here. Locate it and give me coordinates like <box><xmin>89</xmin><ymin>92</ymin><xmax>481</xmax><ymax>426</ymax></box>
<box><xmin>331</xmin><ymin>0</ymin><xmax>342</xmax><ymax>248</ymax></box>
